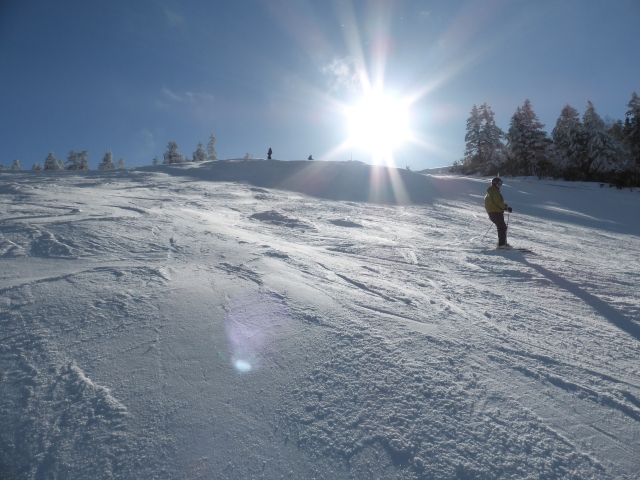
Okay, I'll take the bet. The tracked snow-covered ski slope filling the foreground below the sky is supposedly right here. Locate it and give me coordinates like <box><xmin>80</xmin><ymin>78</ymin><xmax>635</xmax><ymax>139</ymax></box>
<box><xmin>0</xmin><ymin>161</ymin><xmax>640</xmax><ymax>479</ymax></box>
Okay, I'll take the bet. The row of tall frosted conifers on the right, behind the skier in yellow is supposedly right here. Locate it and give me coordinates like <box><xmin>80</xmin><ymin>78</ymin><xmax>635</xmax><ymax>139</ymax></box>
<box><xmin>451</xmin><ymin>92</ymin><xmax>640</xmax><ymax>187</ymax></box>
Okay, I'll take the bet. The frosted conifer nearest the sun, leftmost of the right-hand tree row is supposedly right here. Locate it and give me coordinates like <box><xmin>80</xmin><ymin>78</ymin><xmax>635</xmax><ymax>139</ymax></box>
<box><xmin>462</xmin><ymin>103</ymin><xmax>505</xmax><ymax>175</ymax></box>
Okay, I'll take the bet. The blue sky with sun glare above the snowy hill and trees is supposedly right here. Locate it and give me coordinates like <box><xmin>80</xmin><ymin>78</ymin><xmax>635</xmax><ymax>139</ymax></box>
<box><xmin>0</xmin><ymin>0</ymin><xmax>640</xmax><ymax>170</ymax></box>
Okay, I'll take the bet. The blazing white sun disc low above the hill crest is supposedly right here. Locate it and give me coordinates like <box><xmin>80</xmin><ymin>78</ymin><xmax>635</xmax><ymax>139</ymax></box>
<box><xmin>347</xmin><ymin>93</ymin><xmax>409</xmax><ymax>157</ymax></box>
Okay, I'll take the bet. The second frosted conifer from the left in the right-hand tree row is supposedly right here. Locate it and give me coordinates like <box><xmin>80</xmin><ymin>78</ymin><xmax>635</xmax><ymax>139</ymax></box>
<box><xmin>506</xmin><ymin>100</ymin><xmax>550</xmax><ymax>176</ymax></box>
